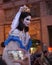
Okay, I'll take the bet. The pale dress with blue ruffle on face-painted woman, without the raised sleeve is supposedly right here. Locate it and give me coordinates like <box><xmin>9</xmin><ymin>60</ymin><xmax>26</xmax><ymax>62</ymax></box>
<box><xmin>2</xmin><ymin>29</ymin><xmax>32</xmax><ymax>65</ymax></box>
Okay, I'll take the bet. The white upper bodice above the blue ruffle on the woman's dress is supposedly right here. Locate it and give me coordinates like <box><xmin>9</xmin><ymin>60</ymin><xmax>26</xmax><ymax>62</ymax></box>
<box><xmin>10</xmin><ymin>29</ymin><xmax>30</xmax><ymax>46</ymax></box>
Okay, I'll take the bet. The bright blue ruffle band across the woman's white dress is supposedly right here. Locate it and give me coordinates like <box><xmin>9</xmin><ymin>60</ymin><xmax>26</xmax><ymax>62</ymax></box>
<box><xmin>4</xmin><ymin>35</ymin><xmax>32</xmax><ymax>51</ymax></box>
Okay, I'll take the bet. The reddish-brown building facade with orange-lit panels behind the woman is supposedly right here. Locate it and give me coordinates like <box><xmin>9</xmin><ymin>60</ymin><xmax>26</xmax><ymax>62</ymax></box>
<box><xmin>0</xmin><ymin>0</ymin><xmax>52</xmax><ymax>54</ymax></box>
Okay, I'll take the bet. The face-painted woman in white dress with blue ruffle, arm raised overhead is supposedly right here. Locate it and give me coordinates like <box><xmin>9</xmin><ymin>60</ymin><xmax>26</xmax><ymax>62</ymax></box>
<box><xmin>2</xmin><ymin>6</ymin><xmax>32</xmax><ymax>65</ymax></box>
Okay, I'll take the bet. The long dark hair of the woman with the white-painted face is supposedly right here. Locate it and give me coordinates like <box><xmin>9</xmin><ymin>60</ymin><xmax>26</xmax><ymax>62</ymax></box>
<box><xmin>16</xmin><ymin>12</ymin><xmax>31</xmax><ymax>32</ymax></box>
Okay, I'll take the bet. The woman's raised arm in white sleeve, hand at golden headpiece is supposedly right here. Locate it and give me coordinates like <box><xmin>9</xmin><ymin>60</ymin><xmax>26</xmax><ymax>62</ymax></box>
<box><xmin>9</xmin><ymin>5</ymin><xmax>30</xmax><ymax>33</ymax></box>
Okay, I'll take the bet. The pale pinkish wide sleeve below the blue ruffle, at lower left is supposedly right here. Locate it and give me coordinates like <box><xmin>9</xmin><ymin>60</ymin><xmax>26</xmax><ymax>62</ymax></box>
<box><xmin>2</xmin><ymin>41</ymin><xmax>20</xmax><ymax>65</ymax></box>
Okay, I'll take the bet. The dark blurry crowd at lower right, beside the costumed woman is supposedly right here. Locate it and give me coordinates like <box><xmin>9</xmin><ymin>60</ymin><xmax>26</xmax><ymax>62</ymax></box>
<box><xmin>31</xmin><ymin>42</ymin><xmax>52</xmax><ymax>65</ymax></box>
